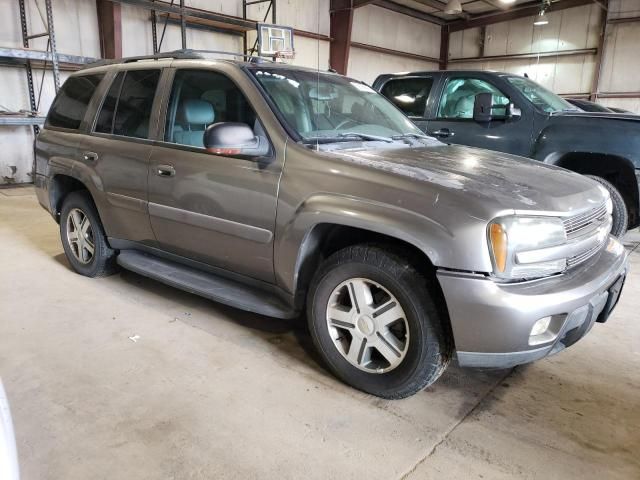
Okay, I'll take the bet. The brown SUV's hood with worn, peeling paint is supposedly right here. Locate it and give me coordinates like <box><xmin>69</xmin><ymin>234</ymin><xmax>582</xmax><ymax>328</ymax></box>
<box><xmin>332</xmin><ymin>145</ymin><xmax>605</xmax><ymax>215</ymax></box>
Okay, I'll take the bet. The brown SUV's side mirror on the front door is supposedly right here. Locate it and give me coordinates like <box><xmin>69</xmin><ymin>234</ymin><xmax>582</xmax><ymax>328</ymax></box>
<box><xmin>204</xmin><ymin>122</ymin><xmax>269</xmax><ymax>157</ymax></box>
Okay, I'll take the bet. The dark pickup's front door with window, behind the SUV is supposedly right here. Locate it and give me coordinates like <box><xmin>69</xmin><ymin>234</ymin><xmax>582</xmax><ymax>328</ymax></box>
<box><xmin>426</xmin><ymin>75</ymin><xmax>533</xmax><ymax>156</ymax></box>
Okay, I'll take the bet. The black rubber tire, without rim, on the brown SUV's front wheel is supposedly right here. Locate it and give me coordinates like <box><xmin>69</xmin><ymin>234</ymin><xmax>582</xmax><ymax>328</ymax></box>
<box><xmin>308</xmin><ymin>249</ymin><xmax>444</xmax><ymax>398</ymax></box>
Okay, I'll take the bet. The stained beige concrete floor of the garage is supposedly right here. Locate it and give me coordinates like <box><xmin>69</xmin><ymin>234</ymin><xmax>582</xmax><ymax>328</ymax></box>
<box><xmin>0</xmin><ymin>188</ymin><xmax>640</xmax><ymax>480</ymax></box>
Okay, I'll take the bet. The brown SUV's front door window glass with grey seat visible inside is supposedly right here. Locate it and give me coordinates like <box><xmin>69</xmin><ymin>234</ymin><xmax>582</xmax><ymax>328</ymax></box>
<box><xmin>164</xmin><ymin>70</ymin><xmax>259</xmax><ymax>148</ymax></box>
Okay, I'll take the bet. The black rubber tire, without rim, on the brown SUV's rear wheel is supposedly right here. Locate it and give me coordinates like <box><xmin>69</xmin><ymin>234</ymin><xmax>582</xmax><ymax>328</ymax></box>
<box><xmin>60</xmin><ymin>192</ymin><xmax>113</xmax><ymax>277</ymax></box>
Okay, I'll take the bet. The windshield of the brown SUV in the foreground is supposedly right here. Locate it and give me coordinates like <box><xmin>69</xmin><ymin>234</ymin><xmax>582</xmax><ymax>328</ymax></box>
<box><xmin>253</xmin><ymin>68</ymin><xmax>424</xmax><ymax>142</ymax></box>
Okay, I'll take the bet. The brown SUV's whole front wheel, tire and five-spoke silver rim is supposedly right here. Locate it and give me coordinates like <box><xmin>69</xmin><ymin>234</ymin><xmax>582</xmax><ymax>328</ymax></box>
<box><xmin>307</xmin><ymin>245</ymin><xmax>452</xmax><ymax>399</ymax></box>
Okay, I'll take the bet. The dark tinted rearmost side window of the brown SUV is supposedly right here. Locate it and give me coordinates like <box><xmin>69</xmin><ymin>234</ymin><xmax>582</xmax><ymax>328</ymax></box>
<box><xmin>45</xmin><ymin>74</ymin><xmax>104</xmax><ymax>130</ymax></box>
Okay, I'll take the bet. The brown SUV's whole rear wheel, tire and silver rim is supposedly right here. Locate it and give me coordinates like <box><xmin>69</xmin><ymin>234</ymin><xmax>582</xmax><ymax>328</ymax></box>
<box><xmin>60</xmin><ymin>191</ymin><xmax>117</xmax><ymax>277</ymax></box>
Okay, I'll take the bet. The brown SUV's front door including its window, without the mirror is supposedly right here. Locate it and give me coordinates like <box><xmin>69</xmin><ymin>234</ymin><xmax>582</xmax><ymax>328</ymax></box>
<box><xmin>149</xmin><ymin>68</ymin><xmax>282</xmax><ymax>281</ymax></box>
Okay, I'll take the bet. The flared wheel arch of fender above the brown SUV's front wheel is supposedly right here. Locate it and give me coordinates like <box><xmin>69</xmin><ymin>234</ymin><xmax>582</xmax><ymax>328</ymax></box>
<box><xmin>275</xmin><ymin>194</ymin><xmax>464</xmax><ymax>293</ymax></box>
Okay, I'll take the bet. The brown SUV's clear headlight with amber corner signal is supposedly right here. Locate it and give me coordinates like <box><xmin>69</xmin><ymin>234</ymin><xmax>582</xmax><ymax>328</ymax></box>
<box><xmin>487</xmin><ymin>216</ymin><xmax>567</xmax><ymax>280</ymax></box>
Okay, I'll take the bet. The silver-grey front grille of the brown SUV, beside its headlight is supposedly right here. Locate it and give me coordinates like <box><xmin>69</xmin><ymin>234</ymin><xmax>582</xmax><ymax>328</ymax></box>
<box><xmin>563</xmin><ymin>203</ymin><xmax>609</xmax><ymax>268</ymax></box>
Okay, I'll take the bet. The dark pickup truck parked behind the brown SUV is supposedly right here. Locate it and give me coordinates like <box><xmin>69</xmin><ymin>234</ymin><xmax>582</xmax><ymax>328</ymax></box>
<box><xmin>373</xmin><ymin>70</ymin><xmax>640</xmax><ymax>237</ymax></box>
